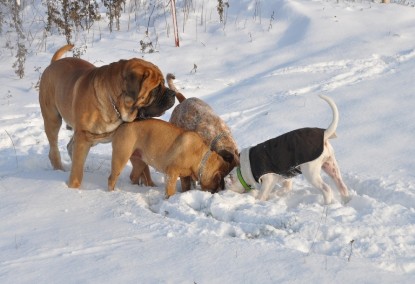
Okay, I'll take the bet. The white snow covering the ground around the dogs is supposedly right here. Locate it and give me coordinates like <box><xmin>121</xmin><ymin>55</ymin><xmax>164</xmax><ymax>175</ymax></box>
<box><xmin>0</xmin><ymin>0</ymin><xmax>415</xmax><ymax>283</ymax></box>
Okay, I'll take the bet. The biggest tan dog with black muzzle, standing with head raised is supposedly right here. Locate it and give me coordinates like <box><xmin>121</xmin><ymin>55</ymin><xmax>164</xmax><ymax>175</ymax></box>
<box><xmin>39</xmin><ymin>45</ymin><xmax>175</xmax><ymax>188</ymax></box>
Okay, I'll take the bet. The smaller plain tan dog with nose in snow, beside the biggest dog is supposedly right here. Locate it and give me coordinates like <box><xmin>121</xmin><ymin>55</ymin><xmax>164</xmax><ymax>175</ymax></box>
<box><xmin>108</xmin><ymin>119</ymin><xmax>230</xmax><ymax>197</ymax></box>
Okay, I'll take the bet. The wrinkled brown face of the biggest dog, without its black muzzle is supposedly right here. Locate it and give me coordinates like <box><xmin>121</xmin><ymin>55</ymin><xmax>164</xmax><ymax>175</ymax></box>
<box><xmin>119</xmin><ymin>58</ymin><xmax>169</xmax><ymax>122</ymax></box>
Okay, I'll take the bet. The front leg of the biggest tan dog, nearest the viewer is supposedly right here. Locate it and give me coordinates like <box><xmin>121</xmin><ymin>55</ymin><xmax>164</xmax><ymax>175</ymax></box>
<box><xmin>68</xmin><ymin>131</ymin><xmax>92</xmax><ymax>188</ymax></box>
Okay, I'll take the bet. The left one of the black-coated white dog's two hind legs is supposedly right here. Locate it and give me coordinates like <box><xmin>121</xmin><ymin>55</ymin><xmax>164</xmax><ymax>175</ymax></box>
<box><xmin>301</xmin><ymin>160</ymin><xmax>333</xmax><ymax>204</ymax></box>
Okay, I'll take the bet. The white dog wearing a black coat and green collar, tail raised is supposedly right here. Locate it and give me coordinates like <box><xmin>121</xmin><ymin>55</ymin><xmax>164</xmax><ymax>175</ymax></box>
<box><xmin>230</xmin><ymin>95</ymin><xmax>350</xmax><ymax>204</ymax></box>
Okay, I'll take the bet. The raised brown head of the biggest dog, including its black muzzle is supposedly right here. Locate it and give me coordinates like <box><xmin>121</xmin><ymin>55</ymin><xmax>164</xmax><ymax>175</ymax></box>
<box><xmin>118</xmin><ymin>58</ymin><xmax>174</xmax><ymax>122</ymax></box>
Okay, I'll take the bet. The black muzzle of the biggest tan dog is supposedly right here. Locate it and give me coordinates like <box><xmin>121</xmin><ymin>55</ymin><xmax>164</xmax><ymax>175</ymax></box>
<box><xmin>137</xmin><ymin>84</ymin><xmax>176</xmax><ymax>120</ymax></box>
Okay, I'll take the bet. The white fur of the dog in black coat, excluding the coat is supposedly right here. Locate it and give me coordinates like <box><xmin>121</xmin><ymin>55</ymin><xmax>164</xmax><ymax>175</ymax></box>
<box><xmin>230</xmin><ymin>95</ymin><xmax>350</xmax><ymax>204</ymax></box>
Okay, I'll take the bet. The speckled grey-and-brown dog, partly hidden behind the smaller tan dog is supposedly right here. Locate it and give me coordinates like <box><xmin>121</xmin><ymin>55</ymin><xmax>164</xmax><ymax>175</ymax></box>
<box><xmin>166</xmin><ymin>74</ymin><xmax>239</xmax><ymax>190</ymax></box>
